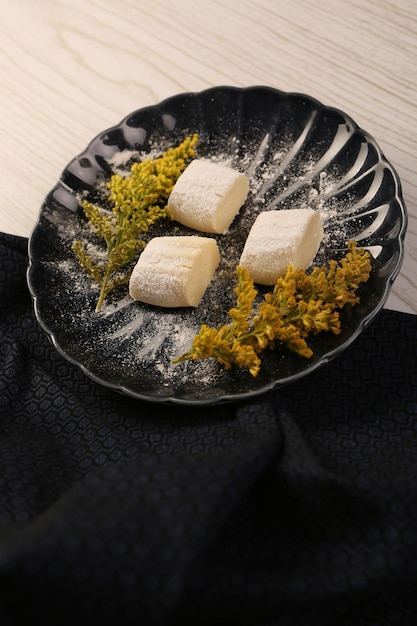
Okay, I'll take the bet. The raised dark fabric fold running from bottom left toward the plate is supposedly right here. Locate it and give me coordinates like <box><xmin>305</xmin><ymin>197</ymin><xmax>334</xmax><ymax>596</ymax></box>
<box><xmin>0</xmin><ymin>398</ymin><xmax>280</xmax><ymax>624</ymax></box>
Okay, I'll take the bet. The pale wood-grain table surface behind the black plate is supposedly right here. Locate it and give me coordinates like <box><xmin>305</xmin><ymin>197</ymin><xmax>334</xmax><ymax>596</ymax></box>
<box><xmin>0</xmin><ymin>0</ymin><xmax>417</xmax><ymax>313</ymax></box>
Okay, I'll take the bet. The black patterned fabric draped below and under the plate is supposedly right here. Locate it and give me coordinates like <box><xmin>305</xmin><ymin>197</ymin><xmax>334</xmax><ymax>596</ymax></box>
<box><xmin>0</xmin><ymin>235</ymin><xmax>417</xmax><ymax>626</ymax></box>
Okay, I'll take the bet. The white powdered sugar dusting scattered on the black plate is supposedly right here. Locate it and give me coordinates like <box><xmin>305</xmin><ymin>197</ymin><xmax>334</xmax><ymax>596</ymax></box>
<box><xmin>48</xmin><ymin>130</ymin><xmax>352</xmax><ymax>389</ymax></box>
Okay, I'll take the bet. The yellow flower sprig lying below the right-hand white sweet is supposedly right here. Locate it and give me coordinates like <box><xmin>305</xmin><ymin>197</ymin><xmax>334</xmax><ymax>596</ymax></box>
<box><xmin>174</xmin><ymin>241</ymin><xmax>372</xmax><ymax>376</ymax></box>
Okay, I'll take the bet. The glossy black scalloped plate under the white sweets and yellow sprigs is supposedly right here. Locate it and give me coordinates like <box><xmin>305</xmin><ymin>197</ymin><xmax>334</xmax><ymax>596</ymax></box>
<box><xmin>28</xmin><ymin>87</ymin><xmax>406</xmax><ymax>404</ymax></box>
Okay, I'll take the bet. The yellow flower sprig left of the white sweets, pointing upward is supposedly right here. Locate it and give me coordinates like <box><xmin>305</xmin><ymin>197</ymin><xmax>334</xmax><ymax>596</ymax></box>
<box><xmin>72</xmin><ymin>135</ymin><xmax>198</xmax><ymax>312</ymax></box>
